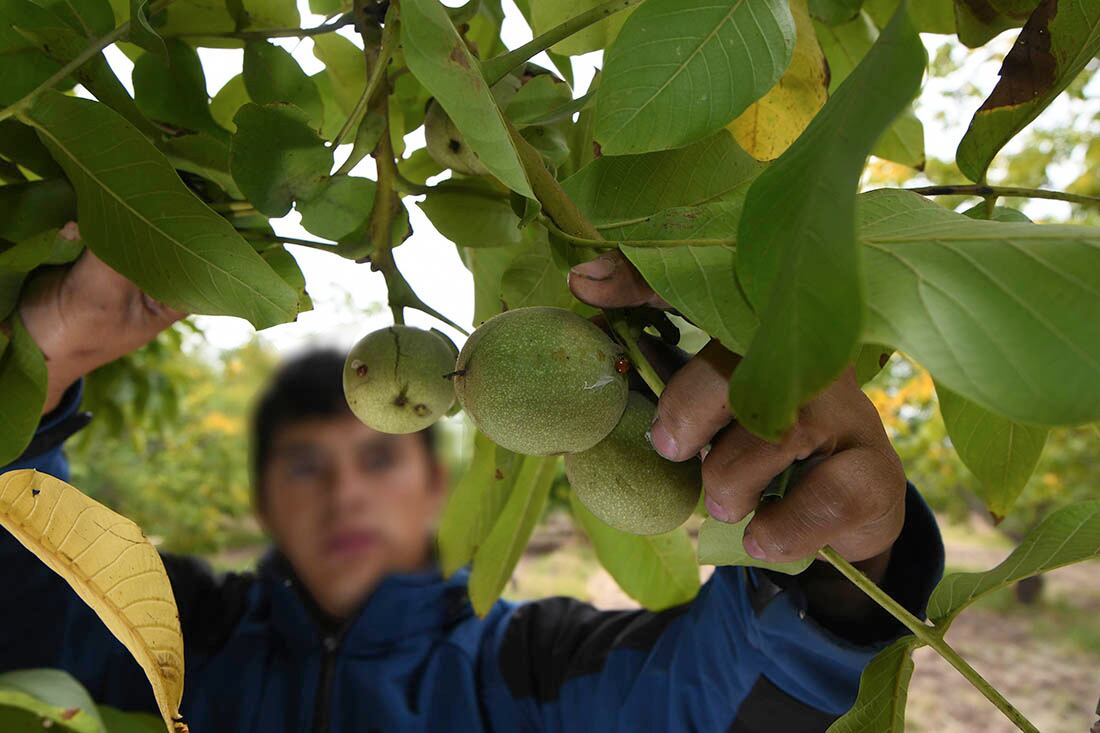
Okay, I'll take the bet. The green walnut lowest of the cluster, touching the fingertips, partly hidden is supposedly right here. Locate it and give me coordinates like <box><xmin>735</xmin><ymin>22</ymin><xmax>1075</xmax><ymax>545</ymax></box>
<box><xmin>565</xmin><ymin>392</ymin><xmax>703</xmax><ymax>535</ymax></box>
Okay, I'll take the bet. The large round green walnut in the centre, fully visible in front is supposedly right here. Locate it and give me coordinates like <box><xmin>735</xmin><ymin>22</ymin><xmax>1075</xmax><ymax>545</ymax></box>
<box><xmin>454</xmin><ymin>307</ymin><xmax>627</xmax><ymax>456</ymax></box>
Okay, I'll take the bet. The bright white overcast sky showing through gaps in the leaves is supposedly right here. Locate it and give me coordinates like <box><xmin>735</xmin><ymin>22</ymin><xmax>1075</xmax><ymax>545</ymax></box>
<box><xmin>107</xmin><ymin>0</ymin><xmax>1091</xmax><ymax>352</ymax></box>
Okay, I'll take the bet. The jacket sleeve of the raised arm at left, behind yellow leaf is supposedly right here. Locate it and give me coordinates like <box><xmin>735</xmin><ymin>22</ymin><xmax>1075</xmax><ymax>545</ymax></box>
<box><xmin>0</xmin><ymin>382</ymin><xmax>251</xmax><ymax>712</ymax></box>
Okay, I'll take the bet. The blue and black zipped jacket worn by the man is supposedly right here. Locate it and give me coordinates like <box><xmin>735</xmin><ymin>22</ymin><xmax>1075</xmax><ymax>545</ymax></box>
<box><xmin>0</xmin><ymin>385</ymin><xmax>943</xmax><ymax>733</ymax></box>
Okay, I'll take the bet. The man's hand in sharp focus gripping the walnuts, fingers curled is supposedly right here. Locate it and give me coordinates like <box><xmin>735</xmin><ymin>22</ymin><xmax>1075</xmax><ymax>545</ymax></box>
<box><xmin>569</xmin><ymin>252</ymin><xmax>905</xmax><ymax>580</ymax></box>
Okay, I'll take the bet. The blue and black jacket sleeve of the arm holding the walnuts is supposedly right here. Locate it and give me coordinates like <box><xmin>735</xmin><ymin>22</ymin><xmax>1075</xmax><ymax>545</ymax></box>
<box><xmin>481</xmin><ymin>484</ymin><xmax>944</xmax><ymax>733</ymax></box>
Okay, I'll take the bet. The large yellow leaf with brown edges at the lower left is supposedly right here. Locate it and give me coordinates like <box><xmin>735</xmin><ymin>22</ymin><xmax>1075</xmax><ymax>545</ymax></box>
<box><xmin>0</xmin><ymin>470</ymin><xmax>187</xmax><ymax>733</ymax></box>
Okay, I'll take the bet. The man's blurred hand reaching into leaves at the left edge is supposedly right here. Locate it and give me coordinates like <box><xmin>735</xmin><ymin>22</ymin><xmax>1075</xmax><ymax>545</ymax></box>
<box><xmin>19</xmin><ymin>222</ymin><xmax>186</xmax><ymax>414</ymax></box>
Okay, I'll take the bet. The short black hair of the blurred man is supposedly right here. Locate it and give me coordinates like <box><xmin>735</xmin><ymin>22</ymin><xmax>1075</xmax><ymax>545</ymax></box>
<box><xmin>250</xmin><ymin>348</ymin><xmax>438</xmax><ymax>508</ymax></box>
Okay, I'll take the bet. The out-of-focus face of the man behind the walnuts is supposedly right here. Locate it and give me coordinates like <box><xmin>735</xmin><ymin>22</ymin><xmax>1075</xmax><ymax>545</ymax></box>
<box><xmin>261</xmin><ymin>415</ymin><xmax>447</xmax><ymax>619</ymax></box>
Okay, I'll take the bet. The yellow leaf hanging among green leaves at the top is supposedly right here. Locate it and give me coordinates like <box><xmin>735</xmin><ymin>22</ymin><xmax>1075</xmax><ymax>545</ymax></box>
<box><xmin>728</xmin><ymin>0</ymin><xmax>828</xmax><ymax>161</ymax></box>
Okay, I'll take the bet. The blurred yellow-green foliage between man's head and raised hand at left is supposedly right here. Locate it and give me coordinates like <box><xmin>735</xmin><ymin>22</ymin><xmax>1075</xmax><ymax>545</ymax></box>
<box><xmin>67</xmin><ymin>328</ymin><xmax>277</xmax><ymax>553</ymax></box>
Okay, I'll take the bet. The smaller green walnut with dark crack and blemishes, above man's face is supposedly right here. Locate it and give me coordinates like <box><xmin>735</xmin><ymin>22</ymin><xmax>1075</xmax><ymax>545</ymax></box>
<box><xmin>343</xmin><ymin>326</ymin><xmax>457</xmax><ymax>433</ymax></box>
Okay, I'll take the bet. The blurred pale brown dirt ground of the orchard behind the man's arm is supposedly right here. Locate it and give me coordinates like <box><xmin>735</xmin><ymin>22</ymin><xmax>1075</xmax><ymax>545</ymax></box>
<box><xmin>508</xmin><ymin>512</ymin><xmax>1100</xmax><ymax>733</ymax></box>
